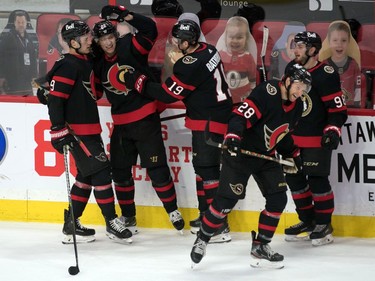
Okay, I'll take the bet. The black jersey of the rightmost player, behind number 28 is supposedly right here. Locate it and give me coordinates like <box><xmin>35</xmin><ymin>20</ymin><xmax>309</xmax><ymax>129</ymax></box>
<box><xmin>293</xmin><ymin>62</ymin><xmax>347</xmax><ymax>147</ymax></box>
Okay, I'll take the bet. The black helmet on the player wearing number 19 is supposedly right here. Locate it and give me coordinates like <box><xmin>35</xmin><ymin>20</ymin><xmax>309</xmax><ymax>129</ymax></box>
<box><xmin>172</xmin><ymin>19</ymin><xmax>201</xmax><ymax>45</ymax></box>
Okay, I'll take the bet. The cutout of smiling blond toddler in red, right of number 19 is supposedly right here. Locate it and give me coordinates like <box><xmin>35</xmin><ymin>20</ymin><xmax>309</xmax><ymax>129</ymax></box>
<box><xmin>216</xmin><ymin>16</ymin><xmax>257</xmax><ymax>104</ymax></box>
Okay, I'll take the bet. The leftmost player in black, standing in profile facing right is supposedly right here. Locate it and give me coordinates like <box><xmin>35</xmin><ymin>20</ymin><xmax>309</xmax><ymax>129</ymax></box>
<box><xmin>48</xmin><ymin>20</ymin><xmax>132</xmax><ymax>243</ymax></box>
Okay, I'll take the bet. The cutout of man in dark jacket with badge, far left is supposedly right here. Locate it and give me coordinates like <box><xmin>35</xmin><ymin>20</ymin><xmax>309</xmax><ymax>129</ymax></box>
<box><xmin>0</xmin><ymin>10</ymin><xmax>38</xmax><ymax>96</ymax></box>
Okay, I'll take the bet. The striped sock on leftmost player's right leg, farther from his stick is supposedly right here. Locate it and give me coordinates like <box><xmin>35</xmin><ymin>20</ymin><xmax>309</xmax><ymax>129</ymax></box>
<box><xmin>94</xmin><ymin>184</ymin><xmax>116</xmax><ymax>220</ymax></box>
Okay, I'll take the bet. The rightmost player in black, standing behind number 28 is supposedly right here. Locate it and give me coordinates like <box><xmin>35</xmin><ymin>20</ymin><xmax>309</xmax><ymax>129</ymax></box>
<box><xmin>285</xmin><ymin>31</ymin><xmax>347</xmax><ymax>246</ymax></box>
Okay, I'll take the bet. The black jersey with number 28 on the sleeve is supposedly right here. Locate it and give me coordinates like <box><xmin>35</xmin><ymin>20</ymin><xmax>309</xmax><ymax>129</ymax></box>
<box><xmin>228</xmin><ymin>80</ymin><xmax>303</xmax><ymax>155</ymax></box>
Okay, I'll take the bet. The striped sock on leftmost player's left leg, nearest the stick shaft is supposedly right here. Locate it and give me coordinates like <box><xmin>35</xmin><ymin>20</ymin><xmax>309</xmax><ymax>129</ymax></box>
<box><xmin>70</xmin><ymin>182</ymin><xmax>91</xmax><ymax>218</ymax></box>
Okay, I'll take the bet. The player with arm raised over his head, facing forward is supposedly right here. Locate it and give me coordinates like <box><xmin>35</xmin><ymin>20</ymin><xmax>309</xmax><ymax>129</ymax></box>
<box><xmin>93</xmin><ymin>6</ymin><xmax>185</xmax><ymax>234</ymax></box>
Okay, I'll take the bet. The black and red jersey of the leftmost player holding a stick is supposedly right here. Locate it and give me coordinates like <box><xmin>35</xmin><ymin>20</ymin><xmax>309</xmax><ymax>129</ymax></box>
<box><xmin>48</xmin><ymin>54</ymin><xmax>102</xmax><ymax>135</ymax></box>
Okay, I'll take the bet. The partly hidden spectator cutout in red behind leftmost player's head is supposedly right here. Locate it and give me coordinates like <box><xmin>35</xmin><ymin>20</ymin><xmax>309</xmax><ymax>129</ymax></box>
<box><xmin>47</xmin><ymin>18</ymin><xmax>72</xmax><ymax>71</ymax></box>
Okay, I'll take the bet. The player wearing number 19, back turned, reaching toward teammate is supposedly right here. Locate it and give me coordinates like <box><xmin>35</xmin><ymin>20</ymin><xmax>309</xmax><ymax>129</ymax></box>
<box><xmin>125</xmin><ymin>19</ymin><xmax>232</xmax><ymax>243</ymax></box>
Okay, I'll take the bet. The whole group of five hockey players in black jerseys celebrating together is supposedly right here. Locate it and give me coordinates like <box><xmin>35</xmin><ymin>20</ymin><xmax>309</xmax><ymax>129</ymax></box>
<box><xmin>38</xmin><ymin>5</ymin><xmax>347</xmax><ymax>268</ymax></box>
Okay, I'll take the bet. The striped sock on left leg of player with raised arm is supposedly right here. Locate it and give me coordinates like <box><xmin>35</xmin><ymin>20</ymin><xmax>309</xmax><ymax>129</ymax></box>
<box><xmin>115</xmin><ymin>179</ymin><xmax>136</xmax><ymax>217</ymax></box>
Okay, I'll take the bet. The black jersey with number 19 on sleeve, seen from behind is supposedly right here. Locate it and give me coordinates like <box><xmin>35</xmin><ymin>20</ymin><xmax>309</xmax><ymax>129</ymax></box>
<box><xmin>145</xmin><ymin>43</ymin><xmax>232</xmax><ymax>134</ymax></box>
